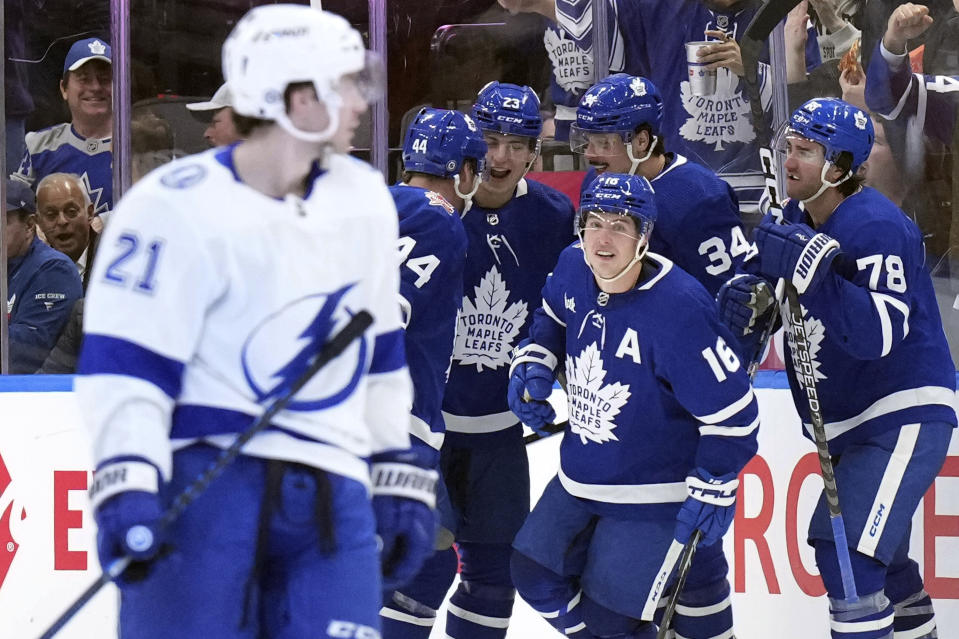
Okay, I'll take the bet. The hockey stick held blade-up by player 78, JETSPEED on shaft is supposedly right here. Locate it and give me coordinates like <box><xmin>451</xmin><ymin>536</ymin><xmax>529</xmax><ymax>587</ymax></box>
<box><xmin>740</xmin><ymin>0</ymin><xmax>859</xmax><ymax>603</ymax></box>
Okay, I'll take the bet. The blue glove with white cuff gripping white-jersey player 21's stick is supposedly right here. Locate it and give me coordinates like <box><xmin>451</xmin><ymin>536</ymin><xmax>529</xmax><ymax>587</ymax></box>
<box><xmin>90</xmin><ymin>460</ymin><xmax>162</xmax><ymax>584</ymax></box>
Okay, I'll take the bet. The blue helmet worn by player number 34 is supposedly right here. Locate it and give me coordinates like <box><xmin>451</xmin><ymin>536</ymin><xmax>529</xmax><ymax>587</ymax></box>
<box><xmin>572</xmin><ymin>73</ymin><xmax>663</xmax><ymax>141</ymax></box>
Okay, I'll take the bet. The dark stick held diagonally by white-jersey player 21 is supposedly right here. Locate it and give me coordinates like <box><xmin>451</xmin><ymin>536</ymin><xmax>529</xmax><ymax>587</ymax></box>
<box><xmin>40</xmin><ymin>311</ymin><xmax>373</xmax><ymax>639</ymax></box>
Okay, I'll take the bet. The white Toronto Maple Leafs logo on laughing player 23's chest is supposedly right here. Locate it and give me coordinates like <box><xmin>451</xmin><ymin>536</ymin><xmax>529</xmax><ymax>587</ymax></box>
<box><xmin>453</xmin><ymin>266</ymin><xmax>527</xmax><ymax>372</ymax></box>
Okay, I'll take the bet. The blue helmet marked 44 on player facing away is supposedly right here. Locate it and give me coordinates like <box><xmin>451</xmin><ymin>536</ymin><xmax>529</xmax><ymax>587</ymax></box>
<box><xmin>403</xmin><ymin>107</ymin><xmax>486</xmax><ymax>178</ymax></box>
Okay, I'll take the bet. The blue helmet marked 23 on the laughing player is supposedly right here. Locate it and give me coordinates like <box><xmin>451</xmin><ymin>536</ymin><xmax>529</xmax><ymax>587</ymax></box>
<box><xmin>473</xmin><ymin>82</ymin><xmax>543</xmax><ymax>138</ymax></box>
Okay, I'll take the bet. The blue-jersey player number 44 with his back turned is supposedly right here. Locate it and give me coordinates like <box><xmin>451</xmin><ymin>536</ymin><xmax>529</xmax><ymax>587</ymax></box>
<box><xmin>380</xmin><ymin>108</ymin><xmax>486</xmax><ymax>637</ymax></box>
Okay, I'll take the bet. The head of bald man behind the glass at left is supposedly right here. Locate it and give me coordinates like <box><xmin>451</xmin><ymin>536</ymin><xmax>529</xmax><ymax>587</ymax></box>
<box><xmin>37</xmin><ymin>173</ymin><xmax>98</xmax><ymax>289</ymax></box>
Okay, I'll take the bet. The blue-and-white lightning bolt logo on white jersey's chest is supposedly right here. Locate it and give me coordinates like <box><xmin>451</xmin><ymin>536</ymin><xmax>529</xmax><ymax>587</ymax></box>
<box><xmin>242</xmin><ymin>284</ymin><xmax>368</xmax><ymax>411</ymax></box>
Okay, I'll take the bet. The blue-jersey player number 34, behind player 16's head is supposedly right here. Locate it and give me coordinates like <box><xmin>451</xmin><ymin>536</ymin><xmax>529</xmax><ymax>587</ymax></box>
<box><xmin>570</xmin><ymin>73</ymin><xmax>750</xmax><ymax>295</ymax></box>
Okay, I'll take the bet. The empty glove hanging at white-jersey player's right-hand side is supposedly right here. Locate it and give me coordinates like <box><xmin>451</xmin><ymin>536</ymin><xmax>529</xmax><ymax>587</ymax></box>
<box><xmin>370</xmin><ymin>449</ymin><xmax>439</xmax><ymax>590</ymax></box>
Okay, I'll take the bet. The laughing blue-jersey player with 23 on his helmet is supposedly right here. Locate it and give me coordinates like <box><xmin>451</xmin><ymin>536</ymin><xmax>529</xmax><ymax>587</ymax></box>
<box><xmin>385</xmin><ymin>82</ymin><xmax>573</xmax><ymax>639</ymax></box>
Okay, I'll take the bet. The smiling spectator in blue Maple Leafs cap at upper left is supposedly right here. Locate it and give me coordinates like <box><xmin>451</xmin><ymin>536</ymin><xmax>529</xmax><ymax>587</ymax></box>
<box><xmin>13</xmin><ymin>38</ymin><xmax>113</xmax><ymax>220</ymax></box>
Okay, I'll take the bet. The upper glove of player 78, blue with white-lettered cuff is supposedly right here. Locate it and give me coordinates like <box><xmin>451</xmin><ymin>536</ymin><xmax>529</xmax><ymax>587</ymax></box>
<box><xmin>754</xmin><ymin>222</ymin><xmax>840</xmax><ymax>295</ymax></box>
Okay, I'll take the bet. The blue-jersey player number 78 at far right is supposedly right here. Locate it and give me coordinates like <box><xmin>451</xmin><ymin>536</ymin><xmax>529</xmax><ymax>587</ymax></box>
<box><xmin>719</xmin><ymin>98</ymin><xmax>957</xmax><ymax>639</ymax></box>
